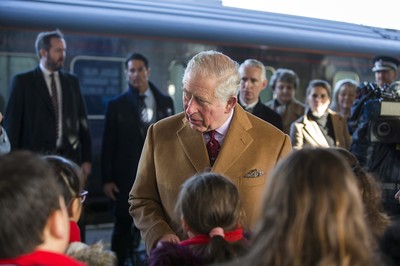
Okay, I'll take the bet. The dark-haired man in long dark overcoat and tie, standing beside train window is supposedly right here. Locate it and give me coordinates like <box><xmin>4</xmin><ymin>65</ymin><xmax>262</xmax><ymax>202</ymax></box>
<box><xmin>102</xmin><ymin>53</ymin><xmax>174</xmax><ymax>265</ymax></box>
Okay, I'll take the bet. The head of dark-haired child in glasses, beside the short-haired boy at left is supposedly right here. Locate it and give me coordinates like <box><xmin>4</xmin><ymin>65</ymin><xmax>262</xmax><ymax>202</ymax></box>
<box><xmin>44</xmin><ymin>155</ymin><xmax>87</xmax><ymax>222</ymax></box>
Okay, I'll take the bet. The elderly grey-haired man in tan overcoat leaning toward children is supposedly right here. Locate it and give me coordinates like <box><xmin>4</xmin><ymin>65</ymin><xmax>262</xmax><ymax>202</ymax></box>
<box><xmin>129</xmin><ymin>51</ymin><xmax>292</xmax><ymax>252</ymax></box>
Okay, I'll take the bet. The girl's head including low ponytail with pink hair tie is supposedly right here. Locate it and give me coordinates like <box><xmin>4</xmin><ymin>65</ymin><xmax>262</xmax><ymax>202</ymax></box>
<box><xmin>176</xmin><ymin>173</ymin><xmax>247</xmax><ymax>263</ymax></box>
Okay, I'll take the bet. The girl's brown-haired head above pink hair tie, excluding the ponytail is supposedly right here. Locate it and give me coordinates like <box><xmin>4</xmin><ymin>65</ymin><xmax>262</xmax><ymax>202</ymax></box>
<box><xmin>176</xmin><ymin>173</ymin><xmax>243</xmax><ymax>235</ymax></box>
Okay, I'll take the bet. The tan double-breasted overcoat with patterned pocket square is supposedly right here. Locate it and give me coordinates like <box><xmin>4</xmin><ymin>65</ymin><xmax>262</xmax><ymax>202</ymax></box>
<box><xmin>129</xmin><ymin>105</ymin><xmax>292</xmax><ymax>252</ymax></box>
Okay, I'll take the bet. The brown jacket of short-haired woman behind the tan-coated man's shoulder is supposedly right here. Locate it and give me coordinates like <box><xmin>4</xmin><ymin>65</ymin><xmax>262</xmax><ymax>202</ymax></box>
<box><xmin>265</xmin><ymin>99</ymin><xmax>305</xmax><ymax>134</ymax></box>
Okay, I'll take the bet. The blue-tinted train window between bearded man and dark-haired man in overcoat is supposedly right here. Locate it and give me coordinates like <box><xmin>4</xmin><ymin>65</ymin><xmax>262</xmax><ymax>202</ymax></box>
<box><xmin>71</xmin><ymin>56</ymin><xmax>126</xmax><ymax>119</ymax></box>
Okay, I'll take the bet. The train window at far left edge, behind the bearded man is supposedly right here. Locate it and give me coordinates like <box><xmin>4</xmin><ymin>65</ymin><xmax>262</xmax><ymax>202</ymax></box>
<box><xmin>0</xmin><ymin>52</ymin><xmax>38</xmax><ymax>113</ymax></box>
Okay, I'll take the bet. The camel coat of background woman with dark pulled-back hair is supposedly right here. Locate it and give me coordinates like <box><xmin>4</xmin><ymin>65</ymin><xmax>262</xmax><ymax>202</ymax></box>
<box><xmin>290</xmin><ymin>109</ymin><xmax>351</xmax><ymax>150</ymax></box>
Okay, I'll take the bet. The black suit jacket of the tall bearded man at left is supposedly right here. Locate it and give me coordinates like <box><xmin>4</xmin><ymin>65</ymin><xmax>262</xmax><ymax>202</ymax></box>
<box><xmin>4</xmin><ymin>66</ymin><xmax>92</xmax><ymax>163</ymax></box>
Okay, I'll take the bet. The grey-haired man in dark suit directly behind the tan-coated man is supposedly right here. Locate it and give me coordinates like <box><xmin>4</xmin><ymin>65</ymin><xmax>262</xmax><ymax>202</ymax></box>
<box><xmin>238</xmin><ymin>59</ymin><xmax>282</xmax><ymax>130</ymax></box>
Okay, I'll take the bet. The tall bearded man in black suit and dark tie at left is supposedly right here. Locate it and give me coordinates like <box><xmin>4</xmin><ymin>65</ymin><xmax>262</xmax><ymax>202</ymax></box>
<box><xmin>4</xmin><ymin>30</ymin><xmax>92</xmax><ymax>176</ymax></box>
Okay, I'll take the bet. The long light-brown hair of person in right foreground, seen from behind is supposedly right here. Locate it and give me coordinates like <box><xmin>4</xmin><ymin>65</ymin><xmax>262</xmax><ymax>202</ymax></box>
<box><xmin>222</xmin><ymin>148</ymin><xmax>379</xmax><ymax>266</ymax></box>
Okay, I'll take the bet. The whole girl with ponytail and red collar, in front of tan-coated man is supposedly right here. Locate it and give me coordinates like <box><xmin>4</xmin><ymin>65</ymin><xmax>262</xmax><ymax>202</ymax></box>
<box><xmin>149</xmin><ymin>173</ymin><xmax>247</xmax><ymax>266</ymax></box>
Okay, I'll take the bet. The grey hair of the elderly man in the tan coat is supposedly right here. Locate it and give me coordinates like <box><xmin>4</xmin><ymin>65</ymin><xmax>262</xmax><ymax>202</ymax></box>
<box><xmin>182</xmin><ymin>50</ymin><xmax>240</xmax><ymax>102</ymax></box>
